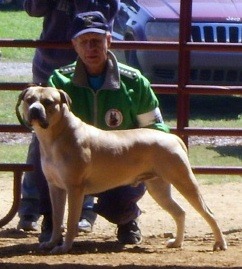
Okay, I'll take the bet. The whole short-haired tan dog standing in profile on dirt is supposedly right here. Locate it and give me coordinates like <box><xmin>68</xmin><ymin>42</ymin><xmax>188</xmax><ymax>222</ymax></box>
<box><xmin>17</xmin><ymin>86</ymin><xmax>227</xmax><ymax>254</ymax></box>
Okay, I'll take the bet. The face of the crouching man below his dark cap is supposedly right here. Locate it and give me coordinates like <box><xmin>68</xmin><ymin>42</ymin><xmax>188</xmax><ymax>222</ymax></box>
<box><xmin>72</xmin><ymin>33</ymin><xmax>111</xmax><ymax>75</ymax></box>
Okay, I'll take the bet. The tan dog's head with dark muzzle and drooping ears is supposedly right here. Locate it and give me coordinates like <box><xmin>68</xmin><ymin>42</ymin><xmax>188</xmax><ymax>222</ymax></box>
<box><xmin>18</xmin><ymin>86</ymin><xmax>71</xmax><ymax>129</ymax></box>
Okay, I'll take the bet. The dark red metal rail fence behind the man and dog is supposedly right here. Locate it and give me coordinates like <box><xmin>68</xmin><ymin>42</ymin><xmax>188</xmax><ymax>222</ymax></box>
<box><xmin>0</xmin><ymin>0</ymin><xmax>242</xmax><ymax>227</ymax></box>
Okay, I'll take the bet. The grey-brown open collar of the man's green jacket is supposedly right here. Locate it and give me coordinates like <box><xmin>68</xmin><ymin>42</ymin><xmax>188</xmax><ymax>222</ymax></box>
<box><xmin>73</xmin><ymin>51</ymin><xmax>120</xmax><ymax>89</ymax></box>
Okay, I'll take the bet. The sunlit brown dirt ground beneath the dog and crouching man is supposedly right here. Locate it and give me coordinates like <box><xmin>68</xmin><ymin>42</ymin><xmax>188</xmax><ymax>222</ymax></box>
<box><xmin>0</xmin><ymin>177</ymin><xmax>242</xmax><ymax>269</ymax></box>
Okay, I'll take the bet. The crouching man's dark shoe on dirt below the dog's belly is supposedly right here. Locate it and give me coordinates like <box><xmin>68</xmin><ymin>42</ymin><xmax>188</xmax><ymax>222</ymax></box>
<box><xmin>117</xmin><ymin>220</ymin><xmax>142</xmax><ymax>245</ymax></box>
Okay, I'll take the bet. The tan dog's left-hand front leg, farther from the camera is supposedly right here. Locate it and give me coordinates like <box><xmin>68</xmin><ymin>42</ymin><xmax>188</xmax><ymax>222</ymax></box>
<box><xmin>40</xmin><ymin>184</ymin><xmax>66</xmax><ymax>249</ymax></box>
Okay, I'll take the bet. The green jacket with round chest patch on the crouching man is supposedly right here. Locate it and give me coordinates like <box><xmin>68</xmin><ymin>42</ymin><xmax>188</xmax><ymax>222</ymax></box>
<box><xmin>49</xmin><ymin>51</ymin><xmax>169</xmax><ymax>132</ymax></box>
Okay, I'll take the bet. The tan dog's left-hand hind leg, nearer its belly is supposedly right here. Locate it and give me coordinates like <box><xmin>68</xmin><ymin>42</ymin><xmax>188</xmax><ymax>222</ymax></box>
<box><xmin>145</xmin><ymin>179</ymin><xmax>185</xmax><ymax>248</ymax></box>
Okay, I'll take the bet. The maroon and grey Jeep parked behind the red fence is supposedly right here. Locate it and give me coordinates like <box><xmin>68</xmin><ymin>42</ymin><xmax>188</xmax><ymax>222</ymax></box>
<box><xmin>113</xmin><ymin>0</ymin><xmax>242</xmax><ymax>86</ymax></box>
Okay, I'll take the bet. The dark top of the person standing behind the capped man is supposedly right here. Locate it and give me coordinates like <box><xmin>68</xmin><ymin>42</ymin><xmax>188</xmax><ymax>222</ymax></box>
<box><xmin>24</xmin><ymin>0</ymin><xmax>119</xmax><ymax>83</ymax></box>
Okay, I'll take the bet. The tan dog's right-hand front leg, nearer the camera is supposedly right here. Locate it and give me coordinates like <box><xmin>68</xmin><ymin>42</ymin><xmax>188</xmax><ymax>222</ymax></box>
<box><xmin>51</xmin><ymin>186</ymin><xmax>84</xmax><ymax>254</ymax></box>
